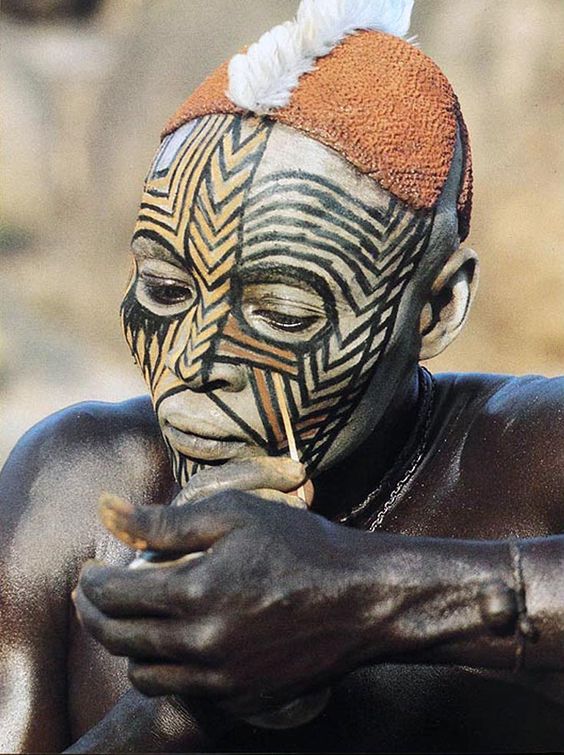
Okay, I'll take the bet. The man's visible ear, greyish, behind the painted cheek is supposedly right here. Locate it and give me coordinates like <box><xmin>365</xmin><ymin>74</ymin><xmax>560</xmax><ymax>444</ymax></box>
<box><xmin>419</xmin><ymin>248</ymin><xmax>478</xmax><ymax>359</ymax></box>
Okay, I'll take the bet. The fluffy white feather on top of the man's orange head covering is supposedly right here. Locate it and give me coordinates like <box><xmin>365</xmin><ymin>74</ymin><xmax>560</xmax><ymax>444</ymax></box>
<box><xmin>226</xmin><ymin>0</ymin><xmax>414</xmax><ymax>113</ymax></box>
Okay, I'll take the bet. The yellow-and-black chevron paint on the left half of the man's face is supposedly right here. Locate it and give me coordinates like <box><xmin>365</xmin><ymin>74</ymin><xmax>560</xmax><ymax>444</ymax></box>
<box><xmin>123</xmin><ymin>116</ymin><xmax>271</xmax><ymax>416</ymax></box>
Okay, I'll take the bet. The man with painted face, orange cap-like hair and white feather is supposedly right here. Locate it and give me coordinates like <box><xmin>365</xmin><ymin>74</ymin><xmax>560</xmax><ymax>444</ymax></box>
<box><xmin>0</xmin><ymin>2</ymin><xmax>564</xmax><ymax>752</ymax></box>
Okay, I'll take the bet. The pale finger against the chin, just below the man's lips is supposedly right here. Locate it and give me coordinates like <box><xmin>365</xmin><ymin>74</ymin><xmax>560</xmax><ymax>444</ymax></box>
<box><xmin>174</xmin><ymin>456</ymin><xmax>306</xmax><ymax>506</ymax></box>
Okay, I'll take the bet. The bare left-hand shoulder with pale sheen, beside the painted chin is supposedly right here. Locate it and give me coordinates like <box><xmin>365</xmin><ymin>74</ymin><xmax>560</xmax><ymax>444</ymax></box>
<box><xmin>0</xmin><ymin>397</ymin><xmax>172</xmax><ymax>568</ymax></box>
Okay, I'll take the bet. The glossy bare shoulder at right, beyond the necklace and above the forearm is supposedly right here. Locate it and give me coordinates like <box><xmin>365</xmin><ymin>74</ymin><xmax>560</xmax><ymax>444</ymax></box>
<box><xmin>436</xmin><ymin>374</ymin><xmax>564</xmax><ymax>526</ymax></box>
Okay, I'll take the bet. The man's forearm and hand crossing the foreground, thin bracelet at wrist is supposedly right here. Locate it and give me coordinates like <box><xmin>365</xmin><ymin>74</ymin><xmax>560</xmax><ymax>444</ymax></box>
<box><xmin>77</xmin><ymin>493</ymin><xmax>564</xmax><ymax>715</ymax></box>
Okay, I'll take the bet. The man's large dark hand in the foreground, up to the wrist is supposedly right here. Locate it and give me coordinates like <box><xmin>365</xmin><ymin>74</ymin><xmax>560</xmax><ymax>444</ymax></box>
<box><xmin>71</xmin><ymin>476</ymin><xmax>378</xmax><ymax>714</ymax></box>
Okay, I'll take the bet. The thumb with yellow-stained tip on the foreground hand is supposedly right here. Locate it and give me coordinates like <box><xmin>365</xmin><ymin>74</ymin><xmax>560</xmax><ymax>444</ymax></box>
<box><xmin>98</xmin><ymin>493</ymin><xmax>234</xmax><ymax>553</ymax></box>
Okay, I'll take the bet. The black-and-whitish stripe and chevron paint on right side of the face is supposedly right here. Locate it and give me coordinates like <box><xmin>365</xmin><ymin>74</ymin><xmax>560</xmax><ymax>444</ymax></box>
<box><xmin>241</xmin><ymin>171</ymin><xmax>433</xmax><ymax>470</ymax></box>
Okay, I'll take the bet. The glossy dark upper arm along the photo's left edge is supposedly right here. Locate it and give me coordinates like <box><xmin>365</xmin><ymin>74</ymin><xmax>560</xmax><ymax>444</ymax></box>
<box><xmin>0</xmin><ymin>410</ymin><xmax>88</xmax><ymax>752</ymax></box>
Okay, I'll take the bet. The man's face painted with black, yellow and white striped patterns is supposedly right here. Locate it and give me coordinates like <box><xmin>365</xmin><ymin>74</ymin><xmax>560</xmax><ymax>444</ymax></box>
<box><xmin>122</xmin><ymin>115</ymin><xmax>432</xmax><ymax>484</ymax></box>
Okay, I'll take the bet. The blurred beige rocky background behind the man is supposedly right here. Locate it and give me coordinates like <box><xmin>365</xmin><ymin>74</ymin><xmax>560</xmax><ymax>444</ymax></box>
<box><xmin>0</xmin><ymin>0</ymin><xmax>564</xmax><ymax>461</ymax></box>
